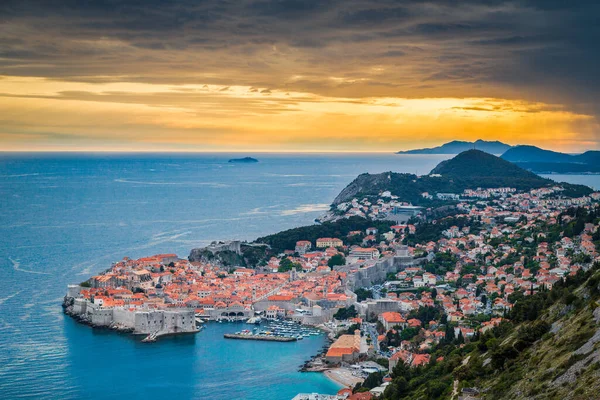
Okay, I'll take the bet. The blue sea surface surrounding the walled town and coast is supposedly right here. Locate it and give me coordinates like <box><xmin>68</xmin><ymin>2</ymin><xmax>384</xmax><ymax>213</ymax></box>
<box><xmin>0</xmin><ymin>153</ymin><xmax>600</xmax><ymax>400</ymax></box>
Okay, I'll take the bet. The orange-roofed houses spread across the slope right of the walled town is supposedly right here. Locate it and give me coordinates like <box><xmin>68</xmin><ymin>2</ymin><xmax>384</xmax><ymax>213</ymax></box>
<box><xmin>304</xmin><ymin>186</ymin><xmax>600</xmax><ymax>396</ymax></box>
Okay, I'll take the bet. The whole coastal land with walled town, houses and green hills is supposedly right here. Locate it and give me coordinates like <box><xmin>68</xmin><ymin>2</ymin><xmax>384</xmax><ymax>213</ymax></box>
<box><xmin>64</xmin><ymin>150</ymin><xmax>600</xmax><ymax>399</ymax></box>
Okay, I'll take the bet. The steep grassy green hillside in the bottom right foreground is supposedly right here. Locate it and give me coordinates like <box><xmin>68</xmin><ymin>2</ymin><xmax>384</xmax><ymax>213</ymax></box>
<box><xmin>383</xmin><ymin>264</ymin><xmax>600</xmax><ymax>400</ymax></box>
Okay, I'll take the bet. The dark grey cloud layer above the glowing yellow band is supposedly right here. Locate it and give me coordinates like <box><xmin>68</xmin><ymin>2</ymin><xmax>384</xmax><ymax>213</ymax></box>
<box><xmin>0</xmin><ymin>0</ymin><xmax>600</xmax><ymax>112</ymax></box>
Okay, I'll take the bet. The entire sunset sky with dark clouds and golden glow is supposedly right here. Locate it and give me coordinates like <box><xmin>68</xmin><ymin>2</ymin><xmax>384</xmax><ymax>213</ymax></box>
<box><xmin>0</xmin><ymin>0</ymin><xmax>600</xmax><ymax>152</ymax></box>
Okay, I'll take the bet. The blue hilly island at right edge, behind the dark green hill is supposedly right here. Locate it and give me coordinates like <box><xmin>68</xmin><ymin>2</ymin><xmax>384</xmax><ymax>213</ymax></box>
<box><xmin>501</xmin><ymin>146</ymin><xmax>600</xmax><ymax>174</ymax></box>
